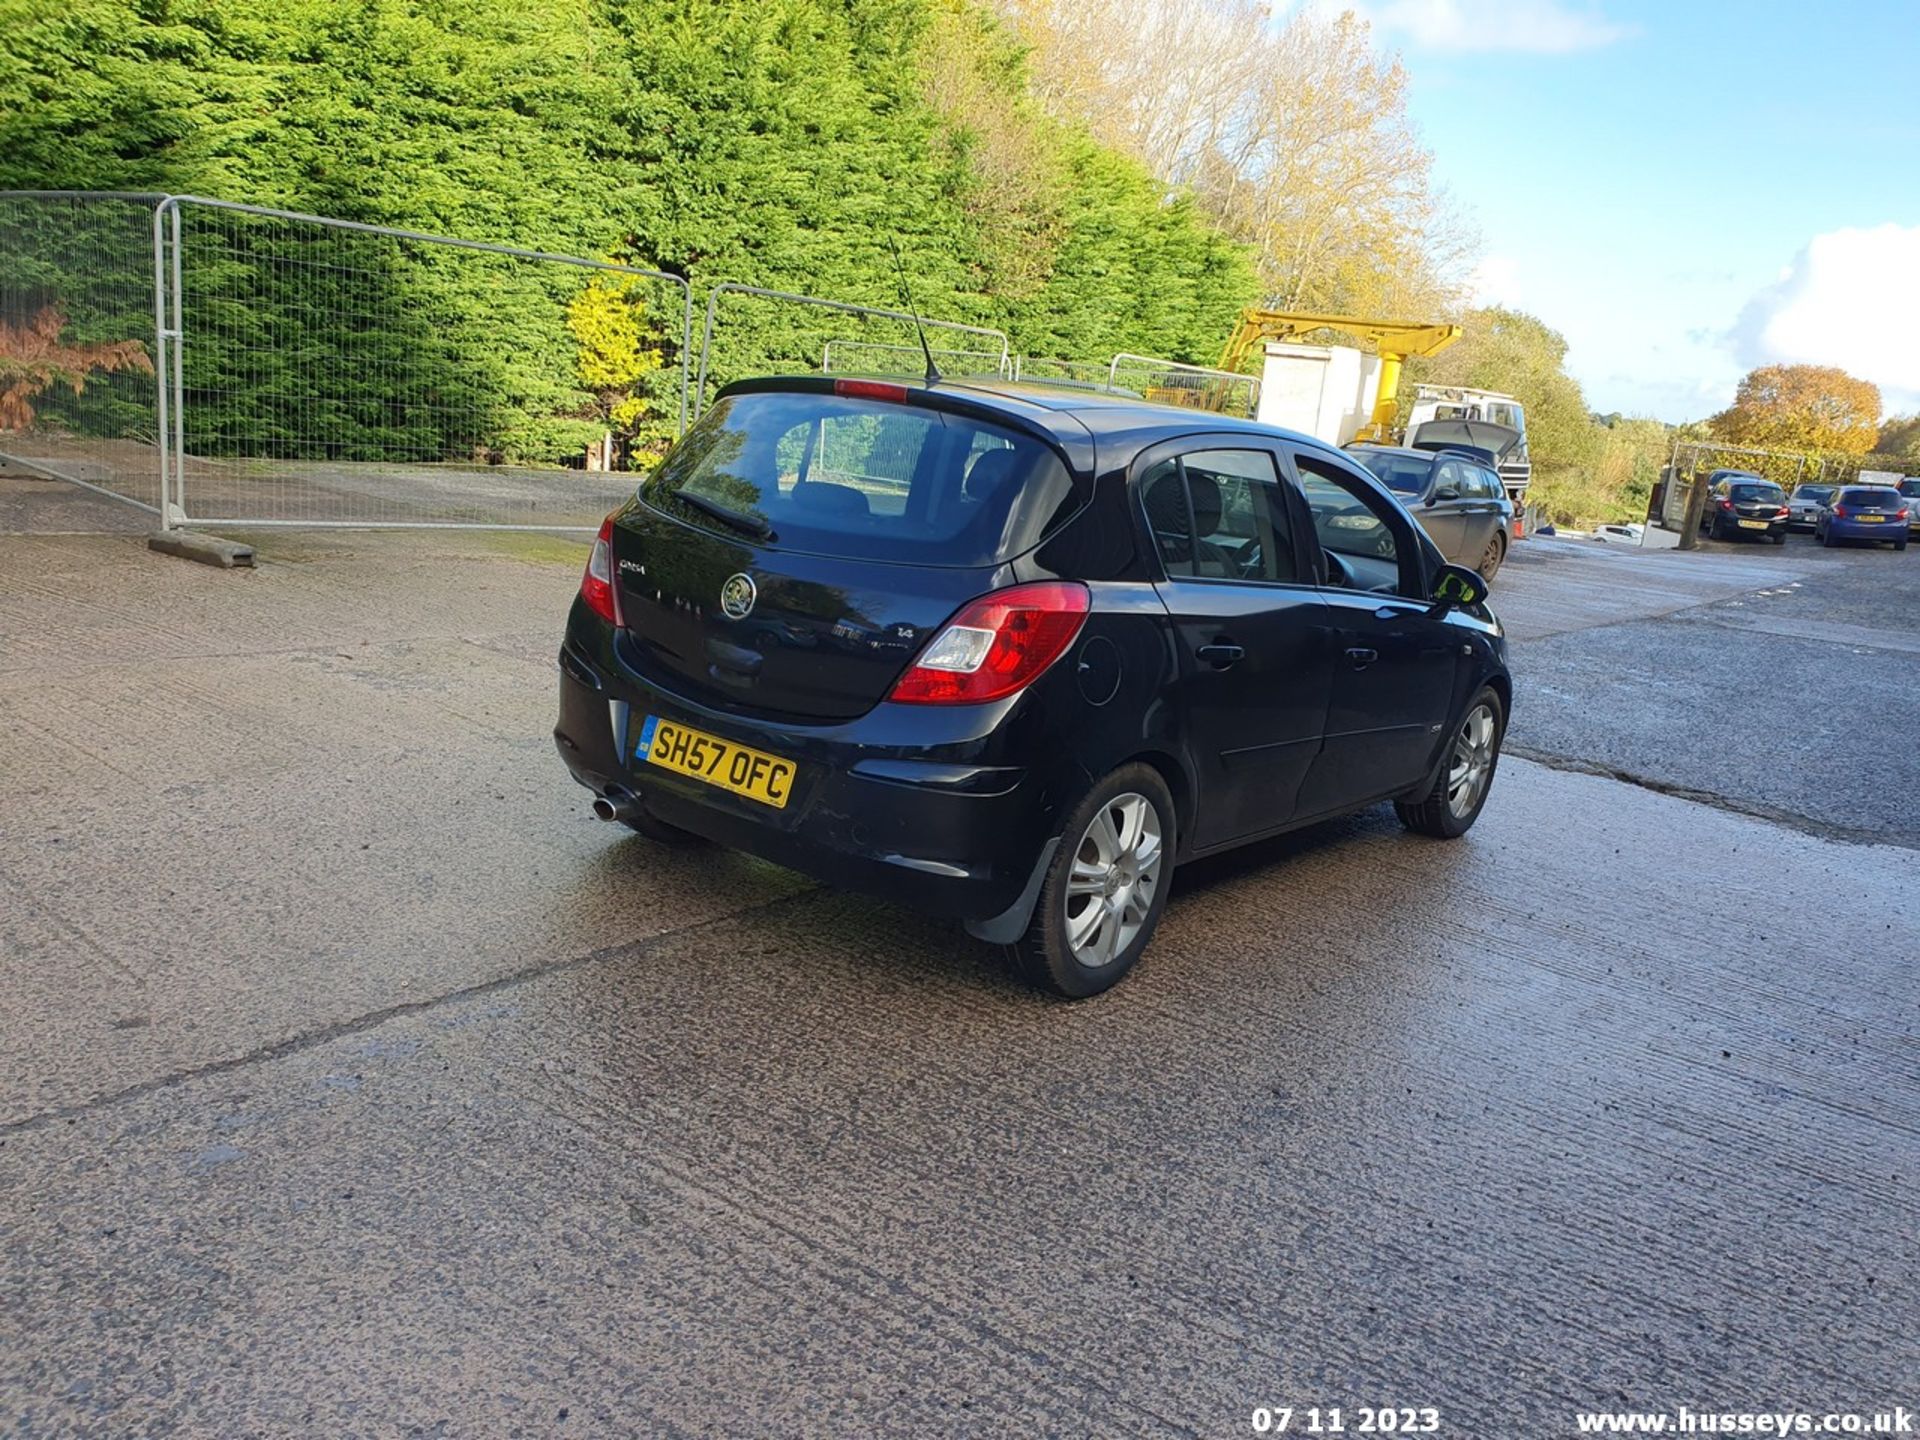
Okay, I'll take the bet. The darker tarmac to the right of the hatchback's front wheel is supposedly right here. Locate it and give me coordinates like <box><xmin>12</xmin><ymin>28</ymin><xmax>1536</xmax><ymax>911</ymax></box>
<box><xmin>1496</xmin><ymin>536</ymin><xmax>1920</xmax><ymax>847</ymax></box>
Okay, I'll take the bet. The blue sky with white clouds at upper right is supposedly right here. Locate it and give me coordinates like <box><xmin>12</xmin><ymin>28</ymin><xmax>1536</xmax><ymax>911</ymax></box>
<box><xmin>1361</xmin><ymin>0</ymin><xmax>1920</xmax><ymax>420</ymax></box>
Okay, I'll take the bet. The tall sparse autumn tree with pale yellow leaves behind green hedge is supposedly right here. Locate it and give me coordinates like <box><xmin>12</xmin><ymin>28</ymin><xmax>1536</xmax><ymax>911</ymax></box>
<box><xmin>1000</xmin><ymin>0</ymin><xmax>1473</xmax><ymax>319</ymax></box>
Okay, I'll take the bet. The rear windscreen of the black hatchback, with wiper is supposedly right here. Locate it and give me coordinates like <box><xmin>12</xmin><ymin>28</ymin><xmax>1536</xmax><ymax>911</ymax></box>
<box><xmin>641</xmin><ymin>392</ymin><xmax>1085</xmax><ymax>566</ymax></box>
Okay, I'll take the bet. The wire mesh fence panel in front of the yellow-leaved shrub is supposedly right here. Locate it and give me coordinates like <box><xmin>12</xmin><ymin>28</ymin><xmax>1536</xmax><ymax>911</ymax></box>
<box><xmin>154</xmin><ymin>196</ymin><xmax>691</xmax><ymax>530</ymax></box>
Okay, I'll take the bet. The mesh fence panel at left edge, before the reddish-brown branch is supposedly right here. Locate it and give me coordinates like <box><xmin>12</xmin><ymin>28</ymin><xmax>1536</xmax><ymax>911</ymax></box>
<box><xmin>0</xmin><ymin>190</ymin><xmax>163</xmax><ymax>515</ymax></box>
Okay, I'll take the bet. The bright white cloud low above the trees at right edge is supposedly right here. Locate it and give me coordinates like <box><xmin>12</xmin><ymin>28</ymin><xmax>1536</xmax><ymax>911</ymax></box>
<box><xmin>1732</xmin><ymin>225</ymin><xmax>1920</xmax><ymax>413</ymax></box>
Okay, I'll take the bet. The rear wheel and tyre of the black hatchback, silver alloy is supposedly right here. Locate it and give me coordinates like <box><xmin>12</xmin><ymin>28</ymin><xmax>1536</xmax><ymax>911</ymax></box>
<box><xmin>1012</xmin><ymin>764</ymin><xmax>1173</xmax><ymax>1000</ymax></box>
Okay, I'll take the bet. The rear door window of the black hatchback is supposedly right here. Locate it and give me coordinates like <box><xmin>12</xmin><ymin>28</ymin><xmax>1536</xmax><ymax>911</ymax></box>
<box><xmin>1140</xmin><ymin>449</ymin><xmax>1298</xmax><ymax>584</ymax></box>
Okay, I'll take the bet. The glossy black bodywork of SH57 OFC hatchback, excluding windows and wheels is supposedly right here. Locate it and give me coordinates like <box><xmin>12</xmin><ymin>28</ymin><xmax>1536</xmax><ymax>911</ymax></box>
<box><xmin>555</xmin><ymin>376</ymin><xmax>1511</xmax><ymax>939</ymax></box>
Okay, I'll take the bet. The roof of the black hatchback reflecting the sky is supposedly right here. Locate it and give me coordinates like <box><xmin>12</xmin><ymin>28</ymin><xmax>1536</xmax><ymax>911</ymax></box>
<box><xmin>716</xmin><ymin>374</ymin><xmax>1352</xmax><ymax>467</ymax></box>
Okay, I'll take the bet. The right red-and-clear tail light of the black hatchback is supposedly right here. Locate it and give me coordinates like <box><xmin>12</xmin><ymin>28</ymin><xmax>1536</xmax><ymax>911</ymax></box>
<box><xmin>889</xmin><ymin>580</ymin><xmax>1089</xmax><ymax>705</ymax></box>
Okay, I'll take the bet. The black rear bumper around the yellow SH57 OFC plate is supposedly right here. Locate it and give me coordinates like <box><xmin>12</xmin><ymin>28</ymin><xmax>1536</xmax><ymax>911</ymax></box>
<box><xmin>553</xmin><ymin>645</ymin><xmax>1085</xmax><ymax>925</ymax></box>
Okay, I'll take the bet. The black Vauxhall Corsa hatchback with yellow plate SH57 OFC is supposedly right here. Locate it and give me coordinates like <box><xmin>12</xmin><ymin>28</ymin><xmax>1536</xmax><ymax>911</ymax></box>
<box><xmin>555</xmin><ymin>376</ymin><xmax>1511</xmax><ymax>996</ymax></box>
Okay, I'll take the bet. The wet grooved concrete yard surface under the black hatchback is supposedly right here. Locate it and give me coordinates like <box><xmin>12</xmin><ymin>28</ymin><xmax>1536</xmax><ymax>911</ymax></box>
<box><xmin>0</xmin><ymin>514</ymin><xmax>1920</xmax><ymax>1436</ymax></box>
